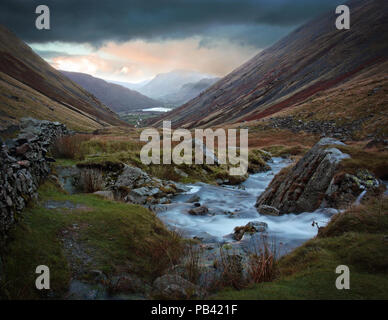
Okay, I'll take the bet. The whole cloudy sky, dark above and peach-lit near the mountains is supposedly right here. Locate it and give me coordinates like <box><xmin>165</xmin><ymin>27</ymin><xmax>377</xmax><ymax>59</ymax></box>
<box><xmin>0</xmin><ymin>0</ymin><xmax>344</xmax><ymax>82</ymax></box>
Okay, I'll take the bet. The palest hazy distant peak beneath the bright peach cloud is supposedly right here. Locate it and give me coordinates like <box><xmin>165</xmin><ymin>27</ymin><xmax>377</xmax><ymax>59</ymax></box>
<box><xmin>138</xmin><ymin>70</ymin><xmax>209</xmax><ymax>99</ymax></box>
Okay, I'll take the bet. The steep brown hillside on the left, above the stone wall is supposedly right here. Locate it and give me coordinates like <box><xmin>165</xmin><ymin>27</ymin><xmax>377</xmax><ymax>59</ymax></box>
<box><xmin>0</xmin><ymin>25</ymin><xmax>127</xmax><ymax>130</ymax></box>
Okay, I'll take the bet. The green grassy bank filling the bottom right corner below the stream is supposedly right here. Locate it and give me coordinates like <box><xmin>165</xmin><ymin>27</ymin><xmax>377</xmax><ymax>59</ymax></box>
<box><xmin>213</xmin><ymin>198</ymin><xmax>388</xmax><ymax>299</ymax></box>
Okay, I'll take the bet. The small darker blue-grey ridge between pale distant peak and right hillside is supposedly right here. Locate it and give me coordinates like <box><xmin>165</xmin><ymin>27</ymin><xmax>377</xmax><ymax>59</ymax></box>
<box><xmin>159</xmin><ymin>78</ymin><xmax>220</xmax><ymax>106</ymax></box>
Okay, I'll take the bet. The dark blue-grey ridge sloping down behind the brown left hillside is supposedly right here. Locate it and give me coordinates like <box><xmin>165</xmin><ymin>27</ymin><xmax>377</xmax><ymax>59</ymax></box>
<box><xmin>61</xmin><ymin>71</ymin><xmax>163</xmax><ymax>113</ymax></box>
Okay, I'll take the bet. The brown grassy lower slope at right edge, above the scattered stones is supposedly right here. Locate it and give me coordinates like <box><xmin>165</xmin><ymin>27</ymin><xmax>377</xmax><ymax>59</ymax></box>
<box><xmin>272</xmin><ymin>61</ymin><xmax>388</xmax><ymax>139</ymax></box>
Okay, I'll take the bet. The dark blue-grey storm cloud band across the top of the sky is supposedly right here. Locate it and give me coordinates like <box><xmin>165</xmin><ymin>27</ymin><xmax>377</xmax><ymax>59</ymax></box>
<box><xmin>0</xmin><ymin>0</ymin><xmax>341</xmax><ymax>46</ymax></box>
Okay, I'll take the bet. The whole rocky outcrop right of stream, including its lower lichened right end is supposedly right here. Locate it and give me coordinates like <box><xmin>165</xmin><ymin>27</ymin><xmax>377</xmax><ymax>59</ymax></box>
<box><xmin>256</xmin><ymin>138</ymin><xmax>382</xmax><ymax>214</ymax></box>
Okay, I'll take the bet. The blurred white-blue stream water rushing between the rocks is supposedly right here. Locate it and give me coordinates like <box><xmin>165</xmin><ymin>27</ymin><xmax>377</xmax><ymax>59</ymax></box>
<box><xmin>158</xmin><ymin>158</ymin><xmax>337</xmax><ymax>252</ymax></box>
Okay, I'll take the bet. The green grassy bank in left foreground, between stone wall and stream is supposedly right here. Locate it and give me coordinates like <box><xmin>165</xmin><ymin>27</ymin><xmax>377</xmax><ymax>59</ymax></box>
<box><xmin>1</xmin><ymin>183</ymin><xmax>182</xmax><ymax>299</ymax></box>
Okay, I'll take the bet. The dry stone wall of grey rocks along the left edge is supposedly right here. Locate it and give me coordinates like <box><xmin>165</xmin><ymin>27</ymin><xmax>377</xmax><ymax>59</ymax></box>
<box><xmin>0</xmin><ymin>118</ymin><xmax>68</xmax><ymax>244</ymax></box>
